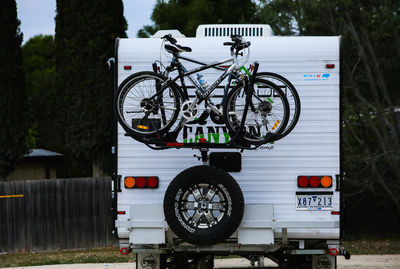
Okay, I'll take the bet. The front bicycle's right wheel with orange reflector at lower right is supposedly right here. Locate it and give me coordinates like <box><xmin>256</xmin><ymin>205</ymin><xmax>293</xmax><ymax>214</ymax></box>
<box><xmin>223</xmin><ymin>78</ymin><xmax>290</xmax><ymax>145</ymax></box>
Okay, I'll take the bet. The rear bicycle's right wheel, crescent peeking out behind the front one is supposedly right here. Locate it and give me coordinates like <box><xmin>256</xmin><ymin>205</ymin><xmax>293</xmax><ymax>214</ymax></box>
<box><xmin>256</xmin><ymin>72</ymin><xmax>301</xmax><ymax>138</ymax></box>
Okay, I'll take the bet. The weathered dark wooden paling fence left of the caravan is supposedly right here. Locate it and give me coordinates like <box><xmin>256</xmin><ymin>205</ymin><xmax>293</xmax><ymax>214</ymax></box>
<box><xmin>0</xmin><ymin>178</ymin><xmax>117</xmax><ymax>252</ymax></box>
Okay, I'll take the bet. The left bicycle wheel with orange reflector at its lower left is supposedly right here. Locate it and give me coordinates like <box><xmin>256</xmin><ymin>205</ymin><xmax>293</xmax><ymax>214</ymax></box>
<box><xmin>114</xmin><ymin>71</ymin><xmax>182</xmax><ymax>142</ymax></box>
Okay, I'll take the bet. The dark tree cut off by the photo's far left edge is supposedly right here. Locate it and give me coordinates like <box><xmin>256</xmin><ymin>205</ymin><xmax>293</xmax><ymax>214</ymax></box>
<box><xmin>0</xmin><ymin>0</ymin><xmax>29</xmax><ymax>179</ymax></box>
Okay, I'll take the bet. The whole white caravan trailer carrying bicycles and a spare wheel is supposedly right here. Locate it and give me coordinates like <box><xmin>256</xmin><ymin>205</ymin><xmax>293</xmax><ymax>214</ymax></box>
<box><xmin>111</xmin><ymin>25</ymin><xmax>349</xmax><ymax>269</ymax></box>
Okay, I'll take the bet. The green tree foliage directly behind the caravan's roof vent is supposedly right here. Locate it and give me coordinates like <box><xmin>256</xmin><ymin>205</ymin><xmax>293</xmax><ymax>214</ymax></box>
<box><xmin>138</xmin><ymin>0</ymin><xmax>257</xmax><ymax>37</ymax></box>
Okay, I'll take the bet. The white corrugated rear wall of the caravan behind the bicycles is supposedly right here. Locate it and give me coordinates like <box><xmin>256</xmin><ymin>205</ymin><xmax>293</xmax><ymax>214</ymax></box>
<box><xmin>118</xmin><ymin>37</ymin><xmax>340</xmax><ymax>239</ymax></box>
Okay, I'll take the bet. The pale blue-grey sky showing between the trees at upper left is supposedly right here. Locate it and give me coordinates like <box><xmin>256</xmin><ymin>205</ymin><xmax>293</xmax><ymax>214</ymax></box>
<box><xmin>17</xmin><ymin>0</ymin><xmax>156</xmax><ymax>43</ymax></box>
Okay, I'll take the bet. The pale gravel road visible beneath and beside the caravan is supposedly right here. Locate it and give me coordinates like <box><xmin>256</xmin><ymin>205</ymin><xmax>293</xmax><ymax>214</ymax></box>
<box><xmin>4</xmin><ymin>254</ymin><xmax>400</xmax><ymax>269</ymax></box>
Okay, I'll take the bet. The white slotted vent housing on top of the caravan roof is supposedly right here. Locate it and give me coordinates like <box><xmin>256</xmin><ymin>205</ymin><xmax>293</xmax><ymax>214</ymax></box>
<box><xmin>196</xmin><ymin>24</ymin><xmax>273</xmax><ymax>37</ymax></box>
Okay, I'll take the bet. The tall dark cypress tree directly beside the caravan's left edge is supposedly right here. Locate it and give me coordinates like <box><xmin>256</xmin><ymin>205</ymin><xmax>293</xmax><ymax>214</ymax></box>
<box><xmin>55</xmin><ymin>0</ymin><xmax>126</xmax><ymax>176</ymax></box>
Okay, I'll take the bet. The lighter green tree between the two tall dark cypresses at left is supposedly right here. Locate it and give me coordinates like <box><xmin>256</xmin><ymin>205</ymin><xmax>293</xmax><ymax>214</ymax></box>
<box><xmin>22</xmin><ymin>35</ymin><xmax>62</xmax><ymax>151</ymax></box>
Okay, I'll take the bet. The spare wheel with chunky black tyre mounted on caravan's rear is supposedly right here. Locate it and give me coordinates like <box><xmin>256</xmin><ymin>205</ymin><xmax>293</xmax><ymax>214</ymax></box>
<box><xmin>164</xmin><ymin>165</ymin><xmax>244</xmax><ymax>245</ymax></box>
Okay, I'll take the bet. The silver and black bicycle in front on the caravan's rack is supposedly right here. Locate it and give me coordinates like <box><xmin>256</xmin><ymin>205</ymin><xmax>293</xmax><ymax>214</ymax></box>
<box><xmin>115</xmin><ymin>35</ymin><xmax>290</xmax><ymax>145</ymax></box>
